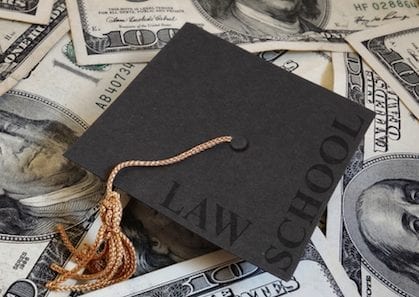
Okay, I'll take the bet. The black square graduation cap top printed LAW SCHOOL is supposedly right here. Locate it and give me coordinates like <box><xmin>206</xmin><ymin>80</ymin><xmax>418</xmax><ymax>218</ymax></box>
<box><xmin>66</xmin><ymin>24</ymin><xmax>373</xmax><ymax>279</ymax></box>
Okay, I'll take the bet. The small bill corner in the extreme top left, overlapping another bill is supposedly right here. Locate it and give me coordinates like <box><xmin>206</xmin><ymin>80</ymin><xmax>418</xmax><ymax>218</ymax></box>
<box><xmin>0</xmin><ymin>0</ymin><xmax>54</xmax><ymax>25</ymax></box>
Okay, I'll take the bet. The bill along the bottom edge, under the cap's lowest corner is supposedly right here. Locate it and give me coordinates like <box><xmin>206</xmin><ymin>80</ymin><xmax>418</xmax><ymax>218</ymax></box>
<box><xmin>86</xmin><ymin>229</ymin><xmax>358</xmax><ymax>297</ymax></box>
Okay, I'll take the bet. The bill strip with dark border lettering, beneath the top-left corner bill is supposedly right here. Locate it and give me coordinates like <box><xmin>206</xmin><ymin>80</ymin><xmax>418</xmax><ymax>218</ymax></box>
<box><xmin>0</xmin><ymin>0</ymin><xmax>69</xmax><ymax>95</ymax></box>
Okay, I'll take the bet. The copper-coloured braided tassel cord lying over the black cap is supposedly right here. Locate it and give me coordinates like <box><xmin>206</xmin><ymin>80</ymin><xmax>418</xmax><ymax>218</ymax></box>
<box><xmin>46</xmin><ymin>136</ymin><xmax>233</xmax><ymax>292</ymax></box>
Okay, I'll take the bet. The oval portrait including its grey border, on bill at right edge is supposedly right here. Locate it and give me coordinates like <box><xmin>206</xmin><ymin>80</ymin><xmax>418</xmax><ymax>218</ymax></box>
<box><xmin>343</xmin><ymin>154</ymin><xmax>419</xmax><ymax>295</ymax></box>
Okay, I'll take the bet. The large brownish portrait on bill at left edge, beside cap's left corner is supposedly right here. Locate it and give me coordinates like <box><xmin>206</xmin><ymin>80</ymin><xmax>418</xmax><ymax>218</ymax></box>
<box><xmin>0</xmin><ymin>94</ymin><xmax>103</xmax><ymax>236</ymax></box>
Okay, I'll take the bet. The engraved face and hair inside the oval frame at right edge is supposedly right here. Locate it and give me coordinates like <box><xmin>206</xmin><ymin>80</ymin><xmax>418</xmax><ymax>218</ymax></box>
<box><xmin>357</xmin><ymin>179</ymin><xmax>419</xmax><ymax>281</ymax></box>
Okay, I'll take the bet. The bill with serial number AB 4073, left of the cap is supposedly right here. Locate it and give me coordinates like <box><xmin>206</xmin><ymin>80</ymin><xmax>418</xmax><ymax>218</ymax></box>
<box><xmin>0</xmin><ymin>36</ymin><xmax>143</xmax><ymax>297</ymax></box>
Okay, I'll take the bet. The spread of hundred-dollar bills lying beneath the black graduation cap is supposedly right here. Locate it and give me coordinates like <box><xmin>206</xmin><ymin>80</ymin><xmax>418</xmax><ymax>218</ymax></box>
<box><xmin>0</xmin><ymin>0</ymin><xmax>419</xmax><ymax>297</ymax></box>
